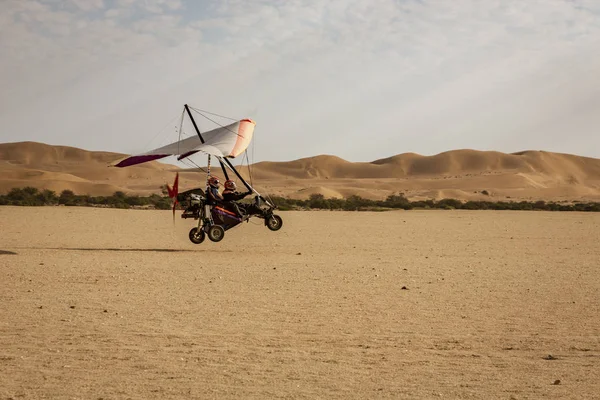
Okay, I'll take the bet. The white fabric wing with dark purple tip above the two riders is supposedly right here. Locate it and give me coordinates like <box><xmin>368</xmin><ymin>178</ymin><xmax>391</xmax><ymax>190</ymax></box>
<box><xmin>115</xmin><ymin>119</ymin><xmax>256</xmax><ymax>167</ymax></box>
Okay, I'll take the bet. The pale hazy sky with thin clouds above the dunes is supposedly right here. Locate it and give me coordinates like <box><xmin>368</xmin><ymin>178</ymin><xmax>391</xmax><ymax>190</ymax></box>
<box><xmin>0</xmin><ymin>0</ymin><xmax>600</xmax><ymax>162</ymax></box>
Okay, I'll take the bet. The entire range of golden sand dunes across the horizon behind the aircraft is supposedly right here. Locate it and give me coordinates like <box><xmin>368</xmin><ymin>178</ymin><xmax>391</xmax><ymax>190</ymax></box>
<box><xmin>0</xmin><ymin>142</ymin><xmax>600</xmax><ymax>201</ymax></box>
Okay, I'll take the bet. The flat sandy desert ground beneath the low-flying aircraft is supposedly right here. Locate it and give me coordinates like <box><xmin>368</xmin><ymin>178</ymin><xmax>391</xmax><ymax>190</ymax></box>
<box><xmin>0</xmin><ymin>207</ymin><xmax>600</xmax><ymax>400</ymax></box>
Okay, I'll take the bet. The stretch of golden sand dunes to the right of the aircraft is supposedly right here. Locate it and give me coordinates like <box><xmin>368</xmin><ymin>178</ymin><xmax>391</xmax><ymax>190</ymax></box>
<box><xmin>240</xmin><ymin>150</ymin><xmax>600</xmax><ymax>200</ymax></box>
